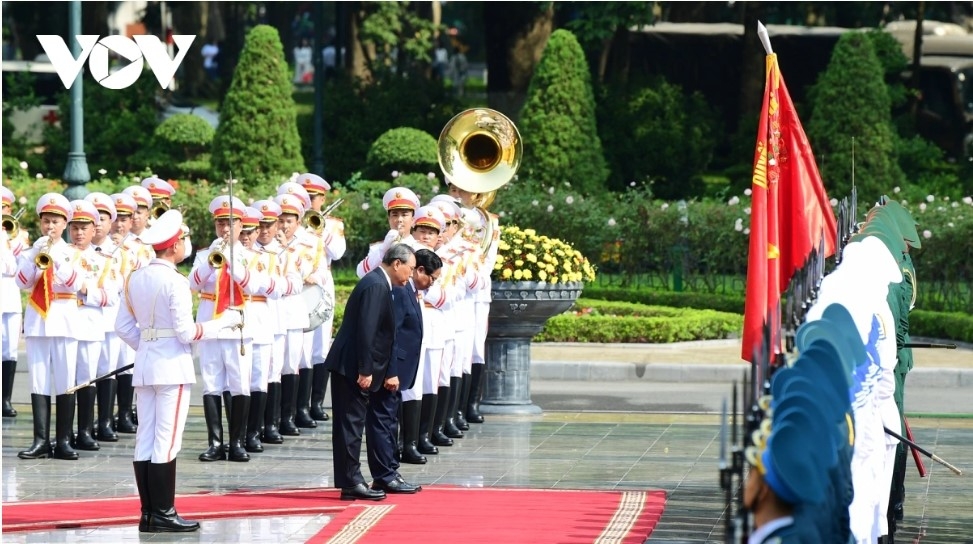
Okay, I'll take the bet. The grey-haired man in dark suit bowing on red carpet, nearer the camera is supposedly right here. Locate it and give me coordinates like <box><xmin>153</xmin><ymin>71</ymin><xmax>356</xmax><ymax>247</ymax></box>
<box><xmin>324</xmin><ymin>244</ymin><xmax>418</xmax><ymax>500</ymax></box>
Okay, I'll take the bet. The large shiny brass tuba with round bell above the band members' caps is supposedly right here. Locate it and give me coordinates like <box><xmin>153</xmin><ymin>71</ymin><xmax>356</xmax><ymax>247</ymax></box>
<box><xmin>438</xmin><ymin>108</ymin><xmax>524</xmax><ymax>250</ymax></box>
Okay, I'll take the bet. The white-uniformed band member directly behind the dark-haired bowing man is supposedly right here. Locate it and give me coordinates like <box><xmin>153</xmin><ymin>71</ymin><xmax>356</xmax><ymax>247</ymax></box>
<box><xmin>400</xmin><ymin>205</ymin><xmax>447</xmax><ymax>465</ymax></box>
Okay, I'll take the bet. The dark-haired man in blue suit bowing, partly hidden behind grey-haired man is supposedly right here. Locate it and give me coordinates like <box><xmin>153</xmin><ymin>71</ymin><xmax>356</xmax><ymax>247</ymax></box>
<box><xmin>392</xmin><ymin>249</ymin><xmax>443</xmax><ymax>466</ymax></box>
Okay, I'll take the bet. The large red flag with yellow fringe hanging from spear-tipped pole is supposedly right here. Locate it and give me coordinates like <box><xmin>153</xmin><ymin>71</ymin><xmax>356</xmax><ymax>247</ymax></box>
<box><xmin>742</xmin><ymin>53</ymin><xmax>837</xmax><ymax>362</ymax></box>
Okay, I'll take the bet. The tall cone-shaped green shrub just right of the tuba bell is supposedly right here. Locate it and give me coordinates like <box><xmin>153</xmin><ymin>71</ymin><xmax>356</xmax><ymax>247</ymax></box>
<box><xmin>518</xmin><ymin>29</ymin><xmax>608</xmax><ymax>194</ymax></box>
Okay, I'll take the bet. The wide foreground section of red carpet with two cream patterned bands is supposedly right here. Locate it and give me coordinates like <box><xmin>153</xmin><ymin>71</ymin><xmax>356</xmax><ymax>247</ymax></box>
<box><xmin>308</xmin><ymin>487</ymin><xmax>666</xmax><ymax>544</ymax></box>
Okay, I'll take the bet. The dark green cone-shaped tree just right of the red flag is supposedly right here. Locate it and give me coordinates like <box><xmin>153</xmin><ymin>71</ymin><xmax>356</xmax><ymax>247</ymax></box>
<box><xmin>807</xmin><ymin>32</ymin><xmax>904</xmax><ymax>205</ymax></box>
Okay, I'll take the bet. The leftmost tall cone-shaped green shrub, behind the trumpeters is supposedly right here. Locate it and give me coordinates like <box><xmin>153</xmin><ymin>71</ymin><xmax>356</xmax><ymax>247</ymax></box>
<box><xmin>212</xmin><ymin>25</ymin><xmax>304</xmax><ymax>183</ymax></box>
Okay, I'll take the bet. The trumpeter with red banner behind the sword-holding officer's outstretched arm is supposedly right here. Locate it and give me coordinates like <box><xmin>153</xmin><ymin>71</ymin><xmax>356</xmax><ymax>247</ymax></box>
<box><xmin>189</xmin><ymin>196</ymin><xmax>267</xmax><ymax>462</ymax></box>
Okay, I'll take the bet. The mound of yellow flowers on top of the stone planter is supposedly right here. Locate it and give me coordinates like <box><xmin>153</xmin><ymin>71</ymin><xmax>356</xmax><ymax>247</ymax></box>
<box><xmin>491</xmin><ymin>225</ymin><xmax>595</xmax><ymax>284</ymax></box>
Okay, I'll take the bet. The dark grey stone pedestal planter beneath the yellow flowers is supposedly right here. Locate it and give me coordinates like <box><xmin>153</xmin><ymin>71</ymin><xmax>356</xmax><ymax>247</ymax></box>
<box><xmin>480</xmin><ymin>281</ymin><xmax>583</xmax><ymax>414</ymax></box>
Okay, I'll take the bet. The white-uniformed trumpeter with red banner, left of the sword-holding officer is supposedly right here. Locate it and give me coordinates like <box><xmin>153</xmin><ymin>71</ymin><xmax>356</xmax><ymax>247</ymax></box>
<box><xmin>15</xmin><ymin>193</ymin><xmax>84</xmax><ymax>460</ymax></box>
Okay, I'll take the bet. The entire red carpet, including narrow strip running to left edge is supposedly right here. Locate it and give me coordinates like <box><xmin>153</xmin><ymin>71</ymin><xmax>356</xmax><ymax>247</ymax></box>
<box><xmin>3</xmin><ymin>487</ymin><xmax>665</xmax><ymax>544</ymax></box>
